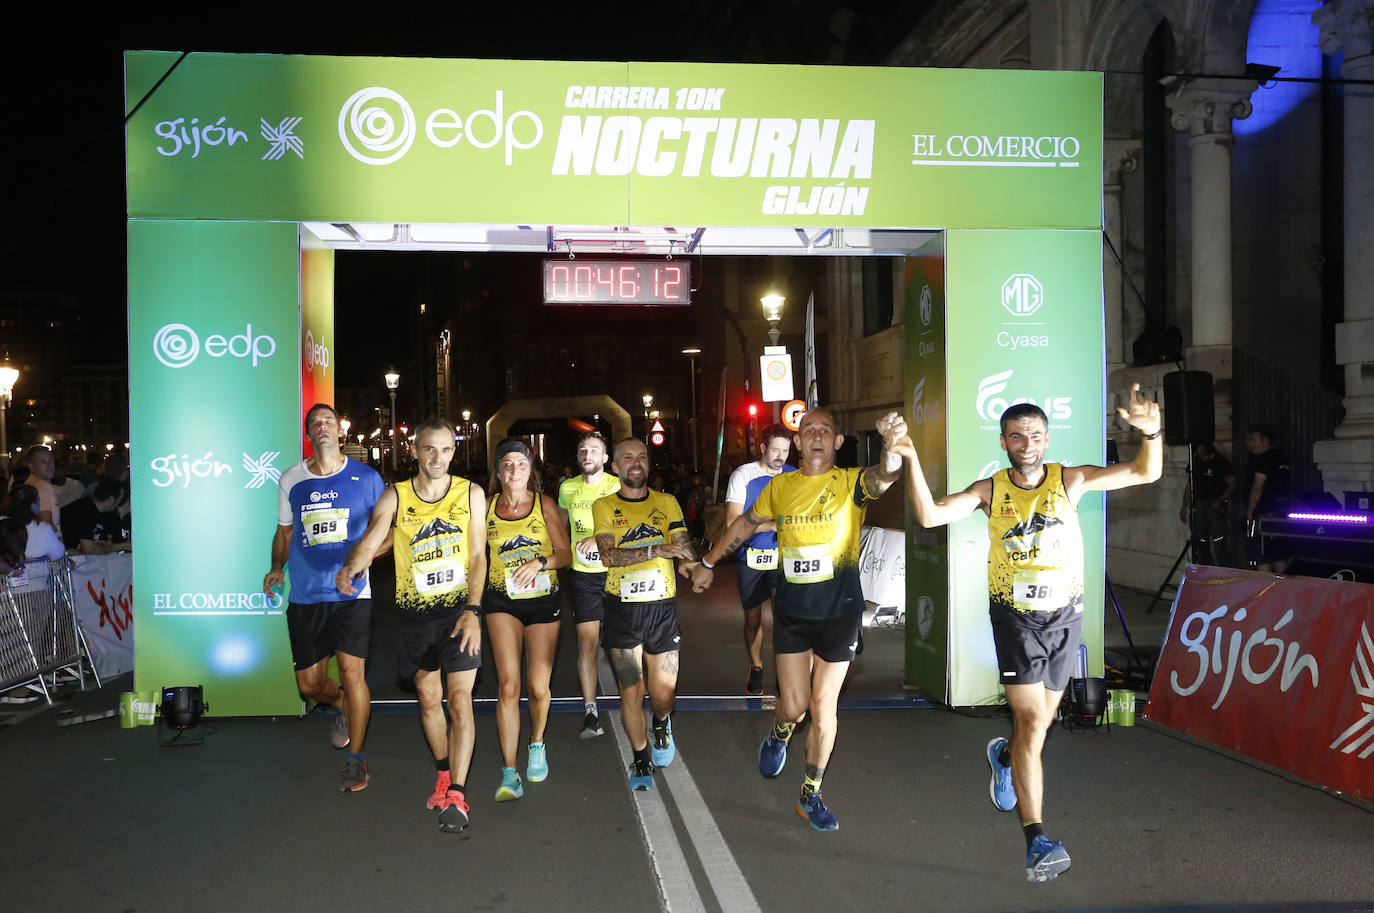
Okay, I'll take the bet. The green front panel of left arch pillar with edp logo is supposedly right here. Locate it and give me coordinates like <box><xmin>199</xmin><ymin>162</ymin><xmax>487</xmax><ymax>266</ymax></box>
<box><xmin>129</xmin><ymin>221</ymin><xmax>301</xmax><ymax>716</ymax></box>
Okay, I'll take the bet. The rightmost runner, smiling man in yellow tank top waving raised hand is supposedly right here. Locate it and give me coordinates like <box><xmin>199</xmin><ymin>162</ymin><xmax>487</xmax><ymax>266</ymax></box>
<box><xmin>896</xmin><ymin>384</ymin><xmax>1164</xmax><ymax>881</ymax></box>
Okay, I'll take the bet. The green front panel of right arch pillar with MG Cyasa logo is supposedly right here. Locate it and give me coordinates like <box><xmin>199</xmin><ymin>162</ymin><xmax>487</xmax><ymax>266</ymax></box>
<box><xmin>936</xmin><ymin>231</ymin><xmax>1106</xmax><ymax>707</ymax></box>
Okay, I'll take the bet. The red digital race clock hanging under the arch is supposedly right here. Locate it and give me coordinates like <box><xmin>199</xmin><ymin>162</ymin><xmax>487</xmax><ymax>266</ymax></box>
<box><xmin>544</xmin><ymin>260</ymin><xmax>691</xmax><ymax>305</ymax></box>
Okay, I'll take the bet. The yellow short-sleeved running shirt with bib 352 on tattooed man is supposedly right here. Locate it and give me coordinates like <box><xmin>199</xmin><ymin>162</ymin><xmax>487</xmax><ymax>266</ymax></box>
<box><xmin>592</xmin><ymin>490</ymin><xmax>687</xmax><ymax>602</ymax></box>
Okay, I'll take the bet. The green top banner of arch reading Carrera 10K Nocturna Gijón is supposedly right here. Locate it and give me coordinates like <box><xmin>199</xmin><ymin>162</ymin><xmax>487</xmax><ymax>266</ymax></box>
<box><xmin>125</xmin><ymin>51</ymin><xmax>1102</xmax><ymax>228</ymax></box>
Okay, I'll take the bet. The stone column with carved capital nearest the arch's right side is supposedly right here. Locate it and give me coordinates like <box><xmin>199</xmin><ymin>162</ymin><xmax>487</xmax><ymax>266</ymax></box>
<box><xmin>1168</xmin><ymin>78</ymin><xmax>1257</xmax><ymax>440</ymax></box>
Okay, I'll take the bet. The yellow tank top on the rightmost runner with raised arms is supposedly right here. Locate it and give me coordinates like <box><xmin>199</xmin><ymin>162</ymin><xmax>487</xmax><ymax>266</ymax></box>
<box><xmin>988</xmin><ymin>463</ymin><xmax>1083</xmax><ymax>627</ymax></box>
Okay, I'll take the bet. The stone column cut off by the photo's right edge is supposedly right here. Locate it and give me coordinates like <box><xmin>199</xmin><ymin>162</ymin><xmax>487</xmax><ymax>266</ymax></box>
<box><xmin>1312</xmin><ymin>0</ymin><xmax>1374</xmax><ymax>495</ymax></box>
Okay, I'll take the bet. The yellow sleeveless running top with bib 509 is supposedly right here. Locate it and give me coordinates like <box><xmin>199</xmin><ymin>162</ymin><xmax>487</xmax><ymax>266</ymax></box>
<box><xmin>393</xmin><ymin>476</ymin><xmax>473</xmax><ymax>617</ymax></box>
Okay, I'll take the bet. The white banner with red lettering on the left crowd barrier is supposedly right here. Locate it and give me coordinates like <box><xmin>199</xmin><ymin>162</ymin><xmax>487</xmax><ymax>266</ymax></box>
<box><xmin>71</xmin><ymin>551</ymin><xmax>133</xmax><ymax>681</ymax></box>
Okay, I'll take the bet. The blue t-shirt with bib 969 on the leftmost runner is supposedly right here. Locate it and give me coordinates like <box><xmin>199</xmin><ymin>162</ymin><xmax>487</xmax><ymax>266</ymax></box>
<box><xmin>276</xmin><ymin>459</ymin><xmax>386</xmax><ymax>604</ymax></box>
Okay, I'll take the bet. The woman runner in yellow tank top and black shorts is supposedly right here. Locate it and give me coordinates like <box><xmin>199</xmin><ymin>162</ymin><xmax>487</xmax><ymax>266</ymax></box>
<box><xmin>482</xmin><ymin>440</ymin><xmax>572</xmax><ymax>802</ymax></box>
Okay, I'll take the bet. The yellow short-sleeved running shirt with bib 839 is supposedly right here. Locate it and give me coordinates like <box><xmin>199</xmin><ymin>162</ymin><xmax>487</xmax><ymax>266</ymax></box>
<box><xmin>750</xmin><ymin>469</ymin><xmax>872</xmax><ymax>619</ymax></box>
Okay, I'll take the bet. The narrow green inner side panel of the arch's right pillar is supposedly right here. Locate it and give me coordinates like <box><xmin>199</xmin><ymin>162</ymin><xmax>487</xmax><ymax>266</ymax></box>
<box><xmin>904</xmin><ymin>234</ymin><xmax>949</xmax><ymax>700</ymax></box>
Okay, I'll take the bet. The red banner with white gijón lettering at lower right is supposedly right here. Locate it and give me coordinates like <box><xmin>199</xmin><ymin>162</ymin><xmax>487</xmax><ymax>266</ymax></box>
<box><xmin>1146</xmin><ymin>565</ymin><xmax>1374</xmax><ymax>799</ymax></box>
